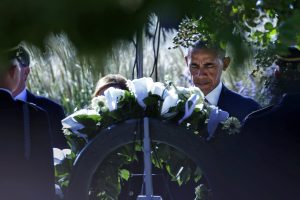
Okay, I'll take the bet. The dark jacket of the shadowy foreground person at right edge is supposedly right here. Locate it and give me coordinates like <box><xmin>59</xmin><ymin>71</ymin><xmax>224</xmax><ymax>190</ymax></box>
<box><xmin>232</xmin><ymin>93</ymin><xmax>300</xmax><ymax>200</ymax></box>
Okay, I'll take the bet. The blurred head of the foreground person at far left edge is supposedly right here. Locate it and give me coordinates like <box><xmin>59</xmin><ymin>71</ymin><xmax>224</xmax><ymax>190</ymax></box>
<box><xmin>0</xmin><ymin>52</ymin><xmax>21</xmax><ymax>92</ymax></box>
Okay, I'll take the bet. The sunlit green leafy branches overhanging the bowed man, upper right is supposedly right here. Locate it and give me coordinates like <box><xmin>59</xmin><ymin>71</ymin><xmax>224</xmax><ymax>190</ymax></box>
<box><xmin>174</xmin><ymin>0</ymin><xmax>300</xmax><ymax>63</ymax></box>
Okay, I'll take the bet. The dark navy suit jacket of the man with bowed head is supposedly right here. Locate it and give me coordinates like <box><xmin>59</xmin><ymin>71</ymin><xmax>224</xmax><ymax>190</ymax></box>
<box><xmin>217</xmin><ymin>85</ymin><xmax>261</xmax><ymax>121</ymax></box>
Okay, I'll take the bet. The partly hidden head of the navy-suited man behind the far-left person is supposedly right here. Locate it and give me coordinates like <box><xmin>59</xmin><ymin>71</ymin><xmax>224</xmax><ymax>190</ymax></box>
<box><xmin>9</xmin><ymin>46</ymin><xmax>30</xmax><ymax>96</ymax></box>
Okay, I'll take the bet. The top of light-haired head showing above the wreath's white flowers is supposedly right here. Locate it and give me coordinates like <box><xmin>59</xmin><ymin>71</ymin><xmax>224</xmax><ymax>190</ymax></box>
<box><xmin>93</xmin><ymin>74</ymin><xmax>128</xmax><ymax>97</ymax></box>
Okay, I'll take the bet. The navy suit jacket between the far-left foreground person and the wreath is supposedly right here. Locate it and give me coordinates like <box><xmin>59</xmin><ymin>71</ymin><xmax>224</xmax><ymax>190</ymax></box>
<box><xmin>27</xmin><ymin>90</ymin><xmax>69</xmax><ymax>149</ymax></box>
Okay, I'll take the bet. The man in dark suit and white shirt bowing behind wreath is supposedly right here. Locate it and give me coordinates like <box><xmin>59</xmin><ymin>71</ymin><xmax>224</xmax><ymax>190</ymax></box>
<box><xmin>186</xmin><ymin>41</ymin><xmax>260</xmax><ymax>121</ymax></box>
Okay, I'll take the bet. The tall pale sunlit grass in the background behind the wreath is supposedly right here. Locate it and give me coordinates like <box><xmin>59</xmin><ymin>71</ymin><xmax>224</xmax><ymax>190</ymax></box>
<box><xmin>27</xmin><ymin>28</ymin><xmax>186</xmax><ymax>114</ymax></box>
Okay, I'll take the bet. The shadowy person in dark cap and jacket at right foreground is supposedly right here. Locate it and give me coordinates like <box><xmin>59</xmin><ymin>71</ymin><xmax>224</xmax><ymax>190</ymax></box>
<box><xmin>236</xmin><ymin>46</ymin><xmax>300</xmax><ymax>200</ymax></box>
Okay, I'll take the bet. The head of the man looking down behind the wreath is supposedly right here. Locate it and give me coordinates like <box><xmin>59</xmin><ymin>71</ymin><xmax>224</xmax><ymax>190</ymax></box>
<box><xmin>186</xmin><ymin>41</ymin><xmax>230</xmax><ymax>95</ymax></box>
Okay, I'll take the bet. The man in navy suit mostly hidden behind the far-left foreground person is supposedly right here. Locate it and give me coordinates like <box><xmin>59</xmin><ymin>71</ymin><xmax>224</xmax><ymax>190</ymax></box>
<box><xmin>13</xmin><ymin>46</ymin><xmax>68</xmax><ymax>149</ymax></box>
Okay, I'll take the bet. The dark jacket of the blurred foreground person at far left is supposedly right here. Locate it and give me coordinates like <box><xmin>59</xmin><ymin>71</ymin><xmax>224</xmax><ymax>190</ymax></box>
<box><xmin>0</xmin><ymin>90</ymin><xmax>54</xmax><ymax>200</ymax></box>
